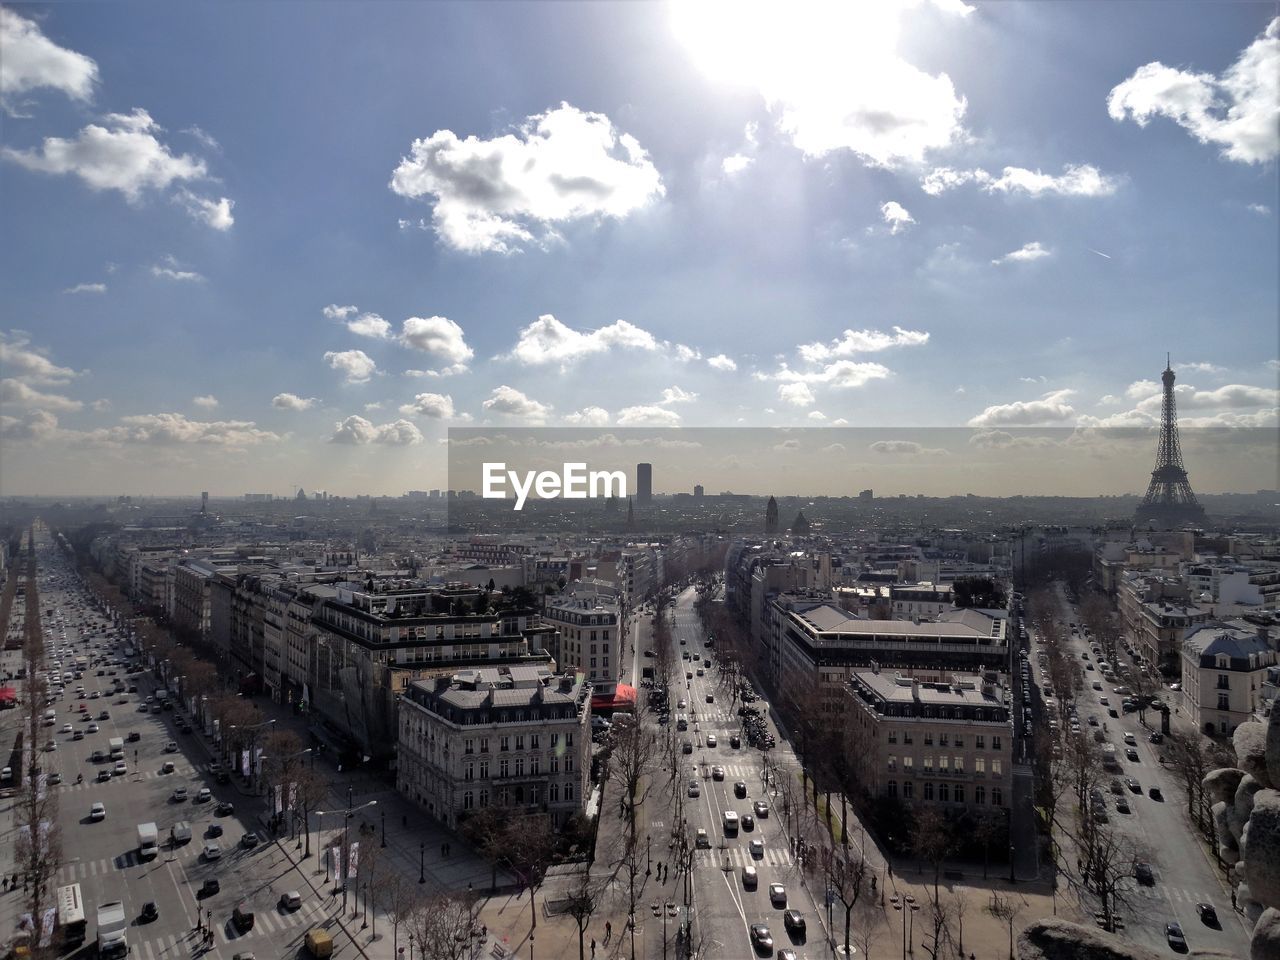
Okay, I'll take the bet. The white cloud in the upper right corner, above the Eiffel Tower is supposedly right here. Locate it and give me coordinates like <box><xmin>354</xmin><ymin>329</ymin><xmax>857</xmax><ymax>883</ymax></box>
<box><xmin>1107</xmin><ymin>17</ymin><xmax>1280</xmax><ymax>164</ymax></box>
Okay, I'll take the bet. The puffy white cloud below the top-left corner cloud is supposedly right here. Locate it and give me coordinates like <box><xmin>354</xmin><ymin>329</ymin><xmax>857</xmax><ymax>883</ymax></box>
<box><xmin>0</xmin><ymin>108</ymin><xmax>209</xmax><ymax>202</ymax></box>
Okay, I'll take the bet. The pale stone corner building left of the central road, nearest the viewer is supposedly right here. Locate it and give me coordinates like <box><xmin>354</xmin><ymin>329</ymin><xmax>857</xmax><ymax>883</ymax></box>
<box><xmin>397</xmin><ymin>667</ymin><xmax>591</xmax><ymax>828</ymax></box>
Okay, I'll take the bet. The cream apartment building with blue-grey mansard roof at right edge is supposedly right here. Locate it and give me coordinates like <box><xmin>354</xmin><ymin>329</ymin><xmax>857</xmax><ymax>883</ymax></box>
<box><xmin>1181</xmin><ymin>620</ymin><xmax>1276</xmax><ymax>736</ymax></box>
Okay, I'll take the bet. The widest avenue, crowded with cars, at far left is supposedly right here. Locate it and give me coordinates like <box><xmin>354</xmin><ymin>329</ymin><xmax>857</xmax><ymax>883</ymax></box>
<box><xmin>0</xmin><ymin>532</ymin><xmax>373</xmax><ymax>960</ymax></box>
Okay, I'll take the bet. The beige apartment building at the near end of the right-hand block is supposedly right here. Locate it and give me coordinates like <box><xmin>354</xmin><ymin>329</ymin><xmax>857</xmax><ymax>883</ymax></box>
<box><xmin>845</xmin><ymin>667</ymin><xmax>1014</xmax><ymax>814</ymax></box>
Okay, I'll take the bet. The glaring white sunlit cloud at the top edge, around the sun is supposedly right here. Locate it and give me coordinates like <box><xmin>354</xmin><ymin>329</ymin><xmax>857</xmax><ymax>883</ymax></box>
<box><xmin>671</xmin><ymin>0</ymin><xmax>966</xmax><ymax>166</ymax></box>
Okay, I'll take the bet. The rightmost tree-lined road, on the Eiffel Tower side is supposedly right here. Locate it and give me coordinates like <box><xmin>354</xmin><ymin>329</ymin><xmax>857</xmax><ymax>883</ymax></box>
<box><xmin>1033</xmin><ymin>591</ymin><xmax>1249</xmax><ymax>956</ymax></box>
